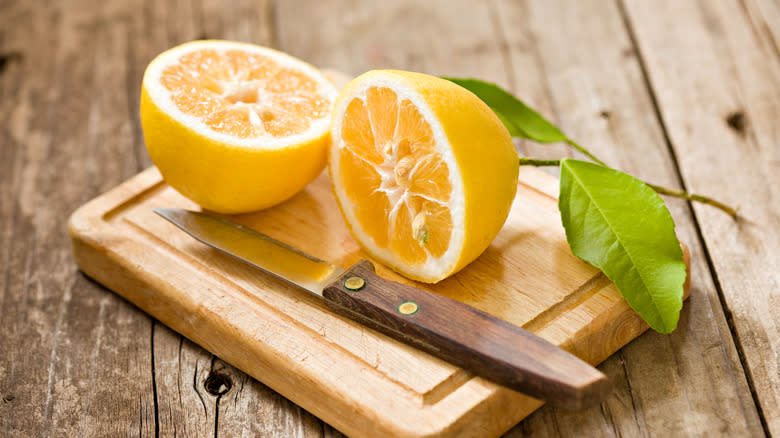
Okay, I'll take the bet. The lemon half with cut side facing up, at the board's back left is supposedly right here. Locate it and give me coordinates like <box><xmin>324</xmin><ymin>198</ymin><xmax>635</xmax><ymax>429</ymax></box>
<box><xmin>141</xmin><ymin>41</ymin><xmax>338</xmax><ymax>213</ymax></box>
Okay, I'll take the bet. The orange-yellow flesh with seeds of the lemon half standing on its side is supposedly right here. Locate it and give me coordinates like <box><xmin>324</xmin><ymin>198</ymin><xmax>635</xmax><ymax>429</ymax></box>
<box><xmin>340</xmin><ymin>88</ymin><xmax>452</xmax><ymax>264</ymax></box>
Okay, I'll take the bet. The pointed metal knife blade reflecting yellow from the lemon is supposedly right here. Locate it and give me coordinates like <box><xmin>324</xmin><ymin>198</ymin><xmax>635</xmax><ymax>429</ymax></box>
<box><xmin>154</xmin><ymin>208</ymin><xmax>344</xmax><ymax>296</ymax></box>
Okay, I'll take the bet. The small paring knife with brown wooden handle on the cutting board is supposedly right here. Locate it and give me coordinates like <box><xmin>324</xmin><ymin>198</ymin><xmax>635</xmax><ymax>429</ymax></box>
<box><xmin>154</xmin><ymin>208</ymin><xmax>611</xmax><ymax>410</ymax></box>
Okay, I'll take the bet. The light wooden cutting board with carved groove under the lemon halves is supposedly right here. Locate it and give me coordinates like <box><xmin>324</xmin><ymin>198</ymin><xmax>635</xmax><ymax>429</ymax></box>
<box><xmin>70</xmin><ymin>168</ymin><xmax>687</xmax><ymax>437</ymax></box>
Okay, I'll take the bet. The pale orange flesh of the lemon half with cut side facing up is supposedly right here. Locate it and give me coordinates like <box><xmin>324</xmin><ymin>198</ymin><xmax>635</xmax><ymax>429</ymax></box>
<box><xmin>160</xmin><ymin>49</ymin><xmax>330</xmax><ymax>138</ymax></box>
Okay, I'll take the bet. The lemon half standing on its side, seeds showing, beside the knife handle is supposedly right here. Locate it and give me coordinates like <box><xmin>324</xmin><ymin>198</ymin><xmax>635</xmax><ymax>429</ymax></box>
<box><xmin>328</xmin><ymin>70</ymin><xmax>518</xmax><ymax>283</ymax></box>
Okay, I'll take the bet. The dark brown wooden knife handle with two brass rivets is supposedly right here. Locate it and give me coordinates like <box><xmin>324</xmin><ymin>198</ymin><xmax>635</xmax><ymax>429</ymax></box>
<box><xmin>323</xmin><ymin>260</ymin><xmax>611</xmax><ymax>410</ymax></box>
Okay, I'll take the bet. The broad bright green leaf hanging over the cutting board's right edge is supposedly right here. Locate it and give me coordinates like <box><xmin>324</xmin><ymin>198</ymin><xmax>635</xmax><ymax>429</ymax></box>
<box><xmin>558</xmin><ymin>159</ymin><xmax>686</xmax><ymax>333</ymax></box>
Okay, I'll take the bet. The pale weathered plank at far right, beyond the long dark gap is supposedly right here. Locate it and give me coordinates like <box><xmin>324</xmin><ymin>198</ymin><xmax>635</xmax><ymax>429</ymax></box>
<box><xmin>626</xmin><ymin>1</ymin><xmax>780</xmax><ymax>434</ymax></box>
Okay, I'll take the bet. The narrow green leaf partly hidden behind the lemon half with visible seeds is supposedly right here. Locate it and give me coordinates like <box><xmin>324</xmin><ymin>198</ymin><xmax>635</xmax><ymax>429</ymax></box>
<box><xmin>443</xmin><ymin>77</ymin><xmax>568</xmax><ymax>143</ymax></box>
